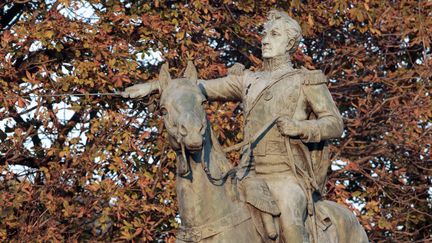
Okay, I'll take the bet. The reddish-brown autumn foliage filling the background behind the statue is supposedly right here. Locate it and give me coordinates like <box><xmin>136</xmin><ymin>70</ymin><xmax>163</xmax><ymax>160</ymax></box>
<box><xmin>0</xmin><ymin>0</ymin><xmax>432</xmax><ymax>242</ymax></box>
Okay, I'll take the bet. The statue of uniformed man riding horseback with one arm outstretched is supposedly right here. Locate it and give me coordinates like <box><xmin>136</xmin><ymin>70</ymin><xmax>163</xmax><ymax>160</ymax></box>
<box><xmin>122</xmin><ymin>11</ymin><xmax>343</xmax><ymax>242</ymax></box>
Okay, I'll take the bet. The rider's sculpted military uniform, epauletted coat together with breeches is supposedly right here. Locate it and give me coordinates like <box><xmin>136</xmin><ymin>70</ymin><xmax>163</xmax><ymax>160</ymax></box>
<box><xmin>200</xmin><ymin>57</ymin><xmax>343</xmax><ymax>241</ymax></box>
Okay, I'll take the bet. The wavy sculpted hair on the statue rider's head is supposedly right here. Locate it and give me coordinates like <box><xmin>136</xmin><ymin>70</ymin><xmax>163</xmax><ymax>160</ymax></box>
<box><xmin>266</xmin><ymin>10</ymin><xmax>302</xmax><ymax>53</ymax></box>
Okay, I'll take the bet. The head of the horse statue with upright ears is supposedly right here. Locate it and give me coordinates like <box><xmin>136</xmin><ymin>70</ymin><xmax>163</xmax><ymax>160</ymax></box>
<box><xmin>159</xmin><ymin>61</ymin><xmax>207</xmax><ymax>153</ymax></box>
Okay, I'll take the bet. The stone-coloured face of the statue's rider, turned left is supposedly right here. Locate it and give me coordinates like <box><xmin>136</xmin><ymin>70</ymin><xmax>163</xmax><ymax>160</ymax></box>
<box><xmin>261</xmin><ymin>20</ymin><xmax>293</xmax><ymax>58</ymax></box>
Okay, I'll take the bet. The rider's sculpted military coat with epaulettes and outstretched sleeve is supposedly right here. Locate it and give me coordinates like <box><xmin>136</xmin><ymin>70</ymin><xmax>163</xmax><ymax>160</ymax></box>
<box><xmin>199</xmin><ymin>63</ymin><xmax>343</xmax><ymax>192</ymax></box>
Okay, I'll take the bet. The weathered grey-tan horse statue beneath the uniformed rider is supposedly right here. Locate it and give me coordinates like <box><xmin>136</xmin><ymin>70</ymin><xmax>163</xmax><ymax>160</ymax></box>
<box><xmin>154</xmin><ymin>62</ymin><xmax>368</xmax><ymax>243</ymax></box>
